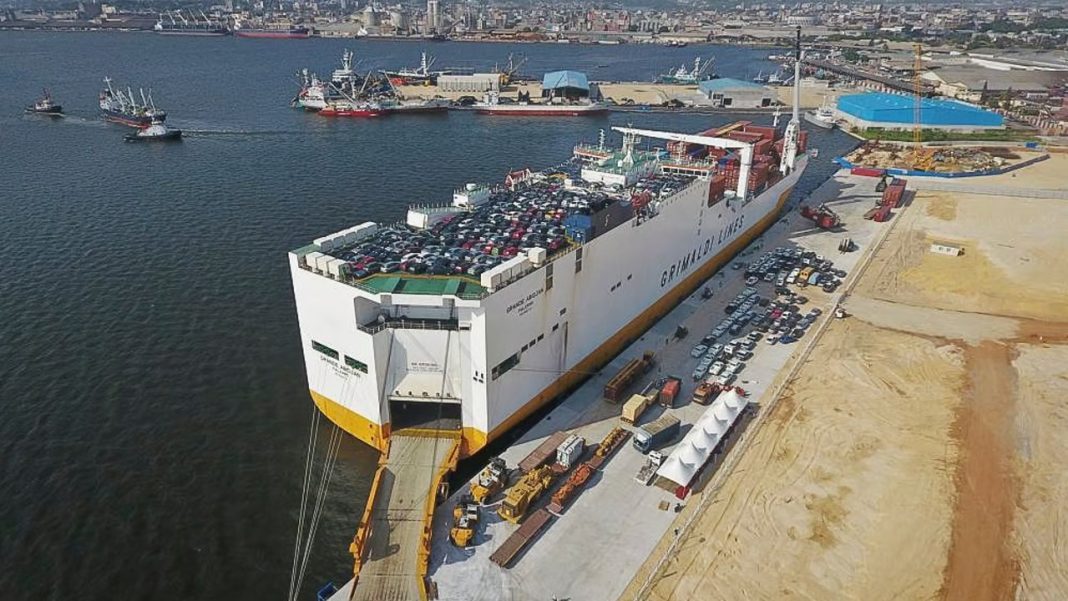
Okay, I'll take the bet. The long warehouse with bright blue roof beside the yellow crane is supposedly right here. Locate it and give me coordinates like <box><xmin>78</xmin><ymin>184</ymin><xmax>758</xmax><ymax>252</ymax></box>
<box><xmin>837</xmin><ymin>93</ymin><xmax>1005</xmax><ymax>131</ymax></box>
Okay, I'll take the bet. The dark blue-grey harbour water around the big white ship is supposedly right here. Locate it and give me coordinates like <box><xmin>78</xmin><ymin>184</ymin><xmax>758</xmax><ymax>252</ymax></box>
<box><xmin>0</xmin><ymin>33</ymin><xmax>849</xmax><ymax>601</ymax></box>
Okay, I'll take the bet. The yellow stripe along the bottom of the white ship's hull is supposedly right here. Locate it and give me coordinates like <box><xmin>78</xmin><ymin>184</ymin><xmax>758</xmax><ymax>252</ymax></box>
<box><xmin>312</xmin><ymin>188</ymin><xmax>794</xmax><ymax>458</ymax></box>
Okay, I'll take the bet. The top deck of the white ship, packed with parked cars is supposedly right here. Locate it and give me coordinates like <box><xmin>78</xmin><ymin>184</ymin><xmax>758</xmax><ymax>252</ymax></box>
<box><xmin>299</xmin><ymin>152</ymin><xmax>711</xmax><ymax>298</ymax></box>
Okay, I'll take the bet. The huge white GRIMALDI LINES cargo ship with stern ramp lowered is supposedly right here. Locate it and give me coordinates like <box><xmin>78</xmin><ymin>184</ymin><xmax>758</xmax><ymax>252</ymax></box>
<box><xmin>288</xmin><ymin>29</ymin><xmax>808</xmax><ymax>600</ymax></box>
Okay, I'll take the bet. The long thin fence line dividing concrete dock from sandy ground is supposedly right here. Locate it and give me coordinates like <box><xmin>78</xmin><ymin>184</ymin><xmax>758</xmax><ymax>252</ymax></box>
<box><xmin>634</xmin><ymin>170</ymin><xmax>900</xmax><ymax>601</ymax></box>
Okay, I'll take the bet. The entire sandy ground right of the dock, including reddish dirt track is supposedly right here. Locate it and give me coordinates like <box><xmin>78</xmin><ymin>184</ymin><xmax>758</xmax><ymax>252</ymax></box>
<box><xmin>622</xmin><ymin>160</ymin><xmax>1068</xmax><ymax>601</ymax></box>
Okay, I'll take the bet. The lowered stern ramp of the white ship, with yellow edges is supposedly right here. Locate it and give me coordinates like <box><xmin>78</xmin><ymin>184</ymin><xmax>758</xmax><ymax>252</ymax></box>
<box><xmin>350</xmin><ymin>429</ymin><xmax>460</xmax><ymax>601</ymax></box>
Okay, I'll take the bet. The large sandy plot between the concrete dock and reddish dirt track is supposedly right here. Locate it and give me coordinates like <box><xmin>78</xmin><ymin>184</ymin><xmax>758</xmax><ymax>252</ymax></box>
<box><xmin>625</xmin><ymin>320</ymin><xmax>963</xmax><ymax>600</ymax></box>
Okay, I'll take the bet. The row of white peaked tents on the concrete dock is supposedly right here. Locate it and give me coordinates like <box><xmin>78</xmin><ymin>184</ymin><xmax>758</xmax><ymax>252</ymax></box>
<box><xmin>657</xmin><ymin>389</ymin><xmax>749</xmax><ymax>486</ymax></box>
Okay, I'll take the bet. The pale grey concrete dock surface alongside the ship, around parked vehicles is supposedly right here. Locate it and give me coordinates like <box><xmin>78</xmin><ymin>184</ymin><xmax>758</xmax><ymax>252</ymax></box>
<box><xmin>427</xmin><ymin>172</ymin><xmax>889</xmax><ymax>601</ymax></box>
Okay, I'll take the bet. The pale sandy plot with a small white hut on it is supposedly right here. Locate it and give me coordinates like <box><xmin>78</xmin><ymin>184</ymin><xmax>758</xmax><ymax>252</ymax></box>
<box><xmin>858</xmin><ymin>193</ymin><xmax>1068</xmax><ymax>320</ymax></box>
